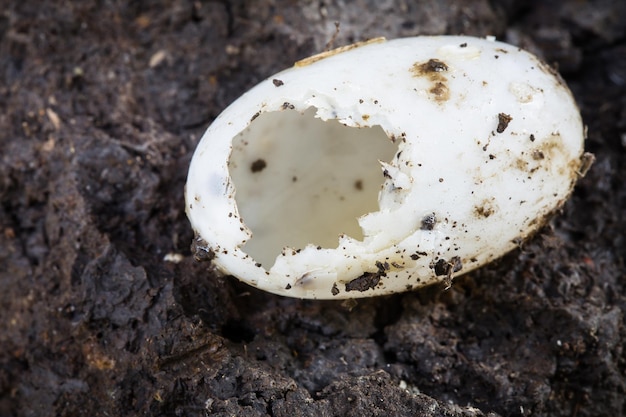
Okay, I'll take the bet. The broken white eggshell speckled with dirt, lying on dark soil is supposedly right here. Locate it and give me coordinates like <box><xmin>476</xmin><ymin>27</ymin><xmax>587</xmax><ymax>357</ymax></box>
<box><xmin>185</xmin><ymin>36</ymin><xmax>585</xmax><ymax>299</ymax></box>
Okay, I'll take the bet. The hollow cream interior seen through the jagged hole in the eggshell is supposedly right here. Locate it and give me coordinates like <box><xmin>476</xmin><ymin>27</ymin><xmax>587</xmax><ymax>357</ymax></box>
<box><xmin>229</xmin><ymin>108</ymin><xmax>398</xmax><ymax>268</ymax></box>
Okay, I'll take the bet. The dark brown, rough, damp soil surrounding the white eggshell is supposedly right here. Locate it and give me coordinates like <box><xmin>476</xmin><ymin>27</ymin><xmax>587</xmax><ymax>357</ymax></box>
<box><xmin>0</xmin><ymin>0</ymin><xmax>626</xmax><ymax>417</ymax></box>
